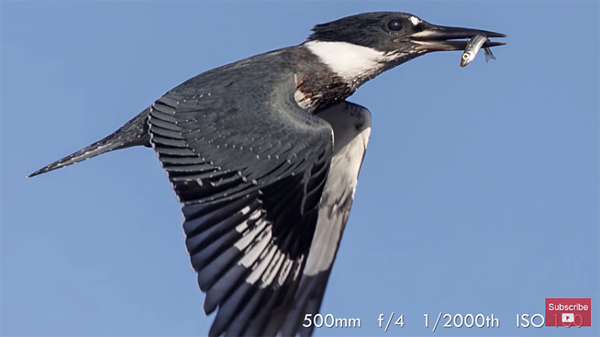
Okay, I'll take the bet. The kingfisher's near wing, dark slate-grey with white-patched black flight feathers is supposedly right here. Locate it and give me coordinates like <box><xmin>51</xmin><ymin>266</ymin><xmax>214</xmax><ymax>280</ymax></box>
<box><xmin>149</xmin><ymin>64</ymin><xmax>333</xmax><ymax>335</ymax></box>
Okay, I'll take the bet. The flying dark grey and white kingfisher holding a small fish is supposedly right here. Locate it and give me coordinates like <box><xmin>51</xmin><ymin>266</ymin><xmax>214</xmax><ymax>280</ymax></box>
<box><xmin>30</xmin><ymin>12</ymin><xmax>506</xmax><ymax>336</ymax></box>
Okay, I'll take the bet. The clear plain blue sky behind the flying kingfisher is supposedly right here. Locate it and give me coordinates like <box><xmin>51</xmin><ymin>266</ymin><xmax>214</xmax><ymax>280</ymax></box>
<box><xmin>0</xmin><ymin>1</ymin><xmax>600</xmax><ymax>336</ymax></box>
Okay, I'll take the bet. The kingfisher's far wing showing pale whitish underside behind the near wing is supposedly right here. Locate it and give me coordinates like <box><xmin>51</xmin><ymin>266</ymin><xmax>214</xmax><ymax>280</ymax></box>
<box><xmin>282</xmin><ymin>102</ymin><xmax>371</xmax><ymax>336</ymax></box>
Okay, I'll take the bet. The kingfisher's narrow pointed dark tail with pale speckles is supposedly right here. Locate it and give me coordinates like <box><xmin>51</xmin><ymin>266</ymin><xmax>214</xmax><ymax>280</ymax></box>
<box><xmin>27</xmin><ymin>109</ymin><xmax>150</xmax><ymax>178</ymax></box>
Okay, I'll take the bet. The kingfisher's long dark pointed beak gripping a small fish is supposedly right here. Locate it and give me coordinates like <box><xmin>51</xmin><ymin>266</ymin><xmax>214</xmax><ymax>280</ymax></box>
<box><xmin>407</xmin><ymin>22</ymin><xmax>506</xmax><ymax>52</ymax></box>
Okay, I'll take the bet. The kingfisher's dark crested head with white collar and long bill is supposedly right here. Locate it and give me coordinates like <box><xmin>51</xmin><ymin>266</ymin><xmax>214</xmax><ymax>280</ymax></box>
<box><xmin>303</xmin><ymin>12</ymin><xmax>506</xmax><ymax>86</ymax></box>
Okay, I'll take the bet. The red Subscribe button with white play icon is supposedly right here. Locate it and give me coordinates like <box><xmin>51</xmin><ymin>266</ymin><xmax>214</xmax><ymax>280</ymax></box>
<box><xmin>546</xmin><ymin>298</ymin><xmax>592</xmax><ymax>327</ymax></box>
